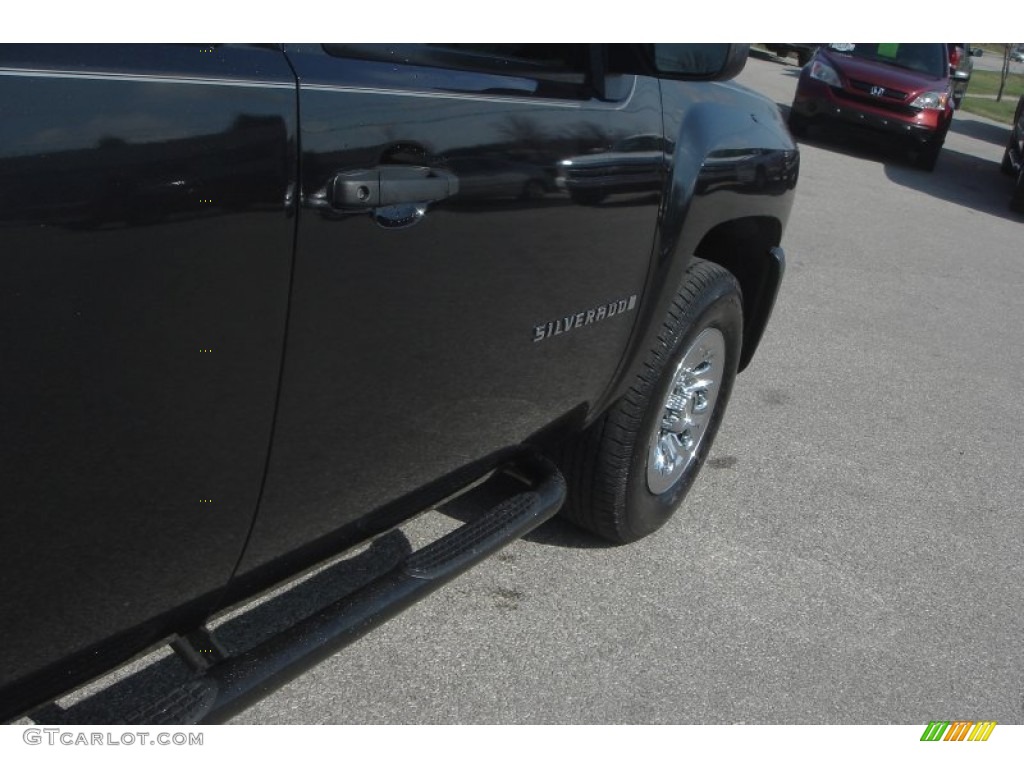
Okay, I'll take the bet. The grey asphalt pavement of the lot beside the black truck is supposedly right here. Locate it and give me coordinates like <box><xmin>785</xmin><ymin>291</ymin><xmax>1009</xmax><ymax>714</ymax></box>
<box><xmin>236</xmin><ymin>58</ymin><xmax>1024</xmax><ymax>724</ymax></box>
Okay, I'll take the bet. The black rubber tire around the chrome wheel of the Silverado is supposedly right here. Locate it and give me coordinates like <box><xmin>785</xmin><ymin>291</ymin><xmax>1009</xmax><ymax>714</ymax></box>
<box><xmin>559</xmin><ymin>259</ymin><xmax>743</xmax><ymax>544</ymax></box>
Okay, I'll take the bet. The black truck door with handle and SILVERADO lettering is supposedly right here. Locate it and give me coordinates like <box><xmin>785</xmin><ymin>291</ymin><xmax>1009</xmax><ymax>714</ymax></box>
<box><xmin>234</xmin><ymin>45</ymin><xmax>665</xmax><ymax>572</ymax></box>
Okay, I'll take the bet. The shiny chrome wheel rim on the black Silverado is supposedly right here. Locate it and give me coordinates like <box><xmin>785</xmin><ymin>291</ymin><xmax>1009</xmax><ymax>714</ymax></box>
<box><xmin>647</xmin><ymin>328</ymin><xmax>725</xmax><ymax>495</ymax></box>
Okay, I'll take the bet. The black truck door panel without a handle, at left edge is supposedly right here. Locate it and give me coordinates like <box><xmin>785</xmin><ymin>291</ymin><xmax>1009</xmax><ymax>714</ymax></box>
<box><xmin>0</xmin><ymin>45</ymin><xmax>297</xmax><ymax>720</ymax></box>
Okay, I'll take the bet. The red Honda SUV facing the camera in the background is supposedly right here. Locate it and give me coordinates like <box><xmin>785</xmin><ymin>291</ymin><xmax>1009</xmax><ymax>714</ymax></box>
<box><xmin>790</xmin><ymin>43</ymin><xmax>953</xmax><ymax>171</ymax></box>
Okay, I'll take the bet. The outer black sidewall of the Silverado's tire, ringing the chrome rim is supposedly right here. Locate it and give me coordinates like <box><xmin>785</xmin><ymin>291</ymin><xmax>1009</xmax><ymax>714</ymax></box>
<box><xmin>625</xmin><ymin>276</ymin><xmax>742</xmax><ymax>539</ymax></box>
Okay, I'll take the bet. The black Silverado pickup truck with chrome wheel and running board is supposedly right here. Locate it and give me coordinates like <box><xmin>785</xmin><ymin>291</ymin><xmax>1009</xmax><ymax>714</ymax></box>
<box><xmin>0</xmin><ymin>44</ymin><xmax>799</xmax><ymax>723</ymax></box>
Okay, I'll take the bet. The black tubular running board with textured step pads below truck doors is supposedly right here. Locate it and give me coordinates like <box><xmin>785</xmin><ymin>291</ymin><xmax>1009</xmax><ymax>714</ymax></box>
<box><xmin>129</xmin><ymin>457</ymin><xmax>565</xmax><ymax>724</ymax></box>
